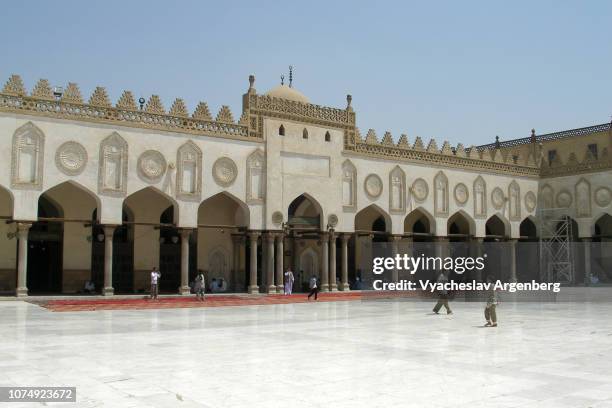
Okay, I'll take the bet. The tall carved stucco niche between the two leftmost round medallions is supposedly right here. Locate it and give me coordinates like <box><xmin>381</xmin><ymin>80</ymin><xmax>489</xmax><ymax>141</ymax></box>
<box><xmin>98</xmin><ymin>132</ymin><xmax>128</xmax><ymax>197</ymax></box>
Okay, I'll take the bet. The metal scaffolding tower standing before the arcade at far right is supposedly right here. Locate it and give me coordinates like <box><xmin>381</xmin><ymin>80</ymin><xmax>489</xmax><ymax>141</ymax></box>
<box><xmin>538</xmin><ymin>208</ymin><xmax>574</xmax><ymax>284</ymax></box>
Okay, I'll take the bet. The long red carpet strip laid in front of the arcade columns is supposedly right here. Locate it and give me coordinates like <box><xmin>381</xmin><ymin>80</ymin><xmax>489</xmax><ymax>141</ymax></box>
<box><xmin>33</xmin><ymin>292</ymin><xmax>418</xmax><ymax>312</ymax></box>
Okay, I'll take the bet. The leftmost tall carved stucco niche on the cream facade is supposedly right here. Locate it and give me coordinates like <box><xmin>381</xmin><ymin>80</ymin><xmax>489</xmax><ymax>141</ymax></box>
<box><xmin>11</xmin><ymin>122</ymin><xmax>45</xmax><ymax>190</ymax></box>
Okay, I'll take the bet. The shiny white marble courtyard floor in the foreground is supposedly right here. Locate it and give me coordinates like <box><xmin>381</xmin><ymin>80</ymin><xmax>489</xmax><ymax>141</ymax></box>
<box><xmin>0</xmin><ymin>300</ymin><xmax>612</xmax><ymax>408</ymax></box>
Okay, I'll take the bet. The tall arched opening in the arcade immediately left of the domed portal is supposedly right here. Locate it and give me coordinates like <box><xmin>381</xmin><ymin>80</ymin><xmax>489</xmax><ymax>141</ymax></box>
<box><xmin>200</xmin><ymin>192</ymin><xmax>250</xmax><ymax>292</ymax></box>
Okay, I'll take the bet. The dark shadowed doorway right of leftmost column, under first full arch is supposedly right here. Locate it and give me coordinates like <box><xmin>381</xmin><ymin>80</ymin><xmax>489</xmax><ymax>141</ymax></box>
<box><xmin>27</xmin><ymin>194</ymin><xmax>64</xmax><ymax>295</ymax></box>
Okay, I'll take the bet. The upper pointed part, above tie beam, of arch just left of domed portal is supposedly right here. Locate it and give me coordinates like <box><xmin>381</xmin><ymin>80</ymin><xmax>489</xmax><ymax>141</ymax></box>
<box><xmin>198</xmin><ymin>191</ymin><xmax>250</xmax><ymax>227</ymax></box>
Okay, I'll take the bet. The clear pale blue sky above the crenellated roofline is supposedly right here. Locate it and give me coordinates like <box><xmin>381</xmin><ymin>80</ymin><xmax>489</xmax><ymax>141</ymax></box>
<box><xmin>0</xmin><ymin>0</ymin><xmax>612</xmax><ymax>146</ymax></box>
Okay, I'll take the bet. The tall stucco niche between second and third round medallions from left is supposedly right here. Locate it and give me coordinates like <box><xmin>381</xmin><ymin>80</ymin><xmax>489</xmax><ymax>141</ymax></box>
<box><xmin>176</xmin><ymin>140</ymin><xmax>202</xmax><ymax>201</ymax></box>
